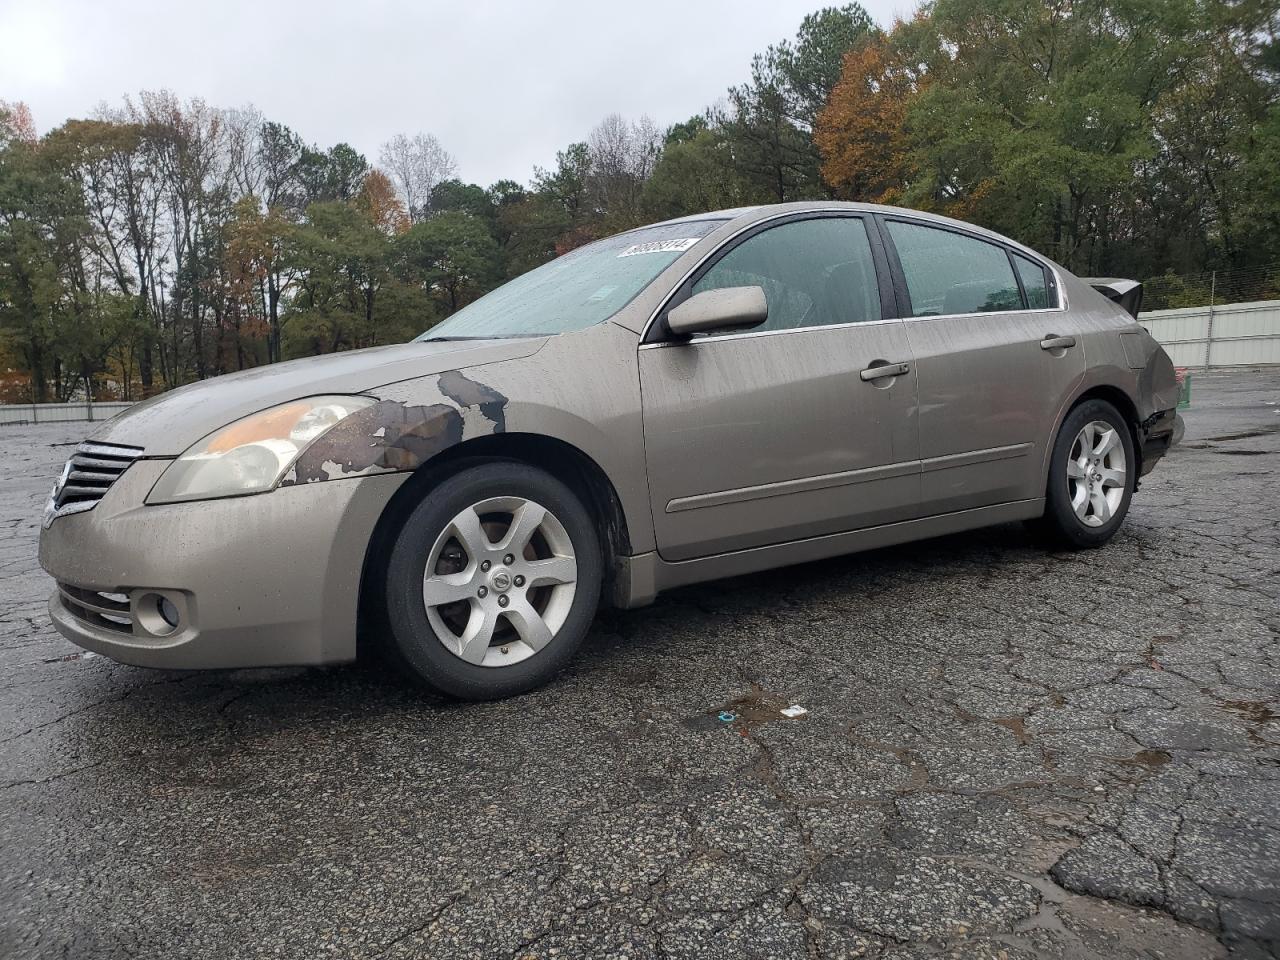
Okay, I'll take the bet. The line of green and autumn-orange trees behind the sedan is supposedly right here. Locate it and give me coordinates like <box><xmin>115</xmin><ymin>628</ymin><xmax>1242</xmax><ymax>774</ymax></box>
<box><xmin>0</xmin><ymin>0</ymin><xmax>1280</xmax><ymax>402</ymax></box>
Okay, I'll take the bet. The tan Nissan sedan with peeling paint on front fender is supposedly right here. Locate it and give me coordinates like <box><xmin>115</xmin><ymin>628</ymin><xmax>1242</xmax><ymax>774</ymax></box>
<box><xmin>40</xmin><ymin>202</ymin><xmax>1181</xmax><ymax>699</ymax></box>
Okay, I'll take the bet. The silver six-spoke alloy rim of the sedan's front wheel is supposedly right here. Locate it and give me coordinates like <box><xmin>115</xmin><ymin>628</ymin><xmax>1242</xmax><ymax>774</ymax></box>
<box><xmin>422</xmin><ymin>497</ymin><xmax>577</xmax><ymax>667</ymax></box>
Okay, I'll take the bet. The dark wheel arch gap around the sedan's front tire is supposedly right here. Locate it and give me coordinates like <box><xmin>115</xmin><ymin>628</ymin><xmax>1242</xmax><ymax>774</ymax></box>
<box><xmin>358</xmin><ymin>433</ymin><xmax>631</xmax><ymax>642</ymax></box>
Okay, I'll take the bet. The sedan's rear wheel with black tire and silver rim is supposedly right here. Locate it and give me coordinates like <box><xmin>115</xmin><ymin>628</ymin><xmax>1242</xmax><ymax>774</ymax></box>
<box><xmin>1036</xmin><ymin>399</ymin><xmax>1138</xmax><ymax>550</ymax></box>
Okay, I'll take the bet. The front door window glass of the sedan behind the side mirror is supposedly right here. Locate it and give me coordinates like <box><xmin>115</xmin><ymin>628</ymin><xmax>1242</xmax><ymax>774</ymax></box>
<box><xmin>694</xmin><ymin>216</ymin><xmax>881</xmax><ymax>330</ymax></box>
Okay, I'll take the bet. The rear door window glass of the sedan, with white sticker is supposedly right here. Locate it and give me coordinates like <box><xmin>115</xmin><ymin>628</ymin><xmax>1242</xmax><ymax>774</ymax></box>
<box><xmin>888</xmin><ymin>220</ymin><xmax>1023</xmax><ymax>316</ymax></box>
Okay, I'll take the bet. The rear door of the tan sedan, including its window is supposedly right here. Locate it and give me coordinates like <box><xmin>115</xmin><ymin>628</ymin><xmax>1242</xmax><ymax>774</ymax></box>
<box><xmin>879</xmin><ymin>216</ymin><xmax>1084</xmax><ymax>516</ymax></box>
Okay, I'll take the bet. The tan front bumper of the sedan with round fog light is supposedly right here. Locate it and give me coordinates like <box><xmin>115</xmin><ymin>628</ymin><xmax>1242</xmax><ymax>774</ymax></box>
<box><xmin>40</xmin><ymin>460</ymin><xmax>407</xmax><ymax>669</ymax></box>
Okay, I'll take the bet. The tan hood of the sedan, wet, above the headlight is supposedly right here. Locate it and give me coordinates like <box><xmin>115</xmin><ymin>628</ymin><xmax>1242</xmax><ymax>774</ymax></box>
<box><xmin>90</xmin><ymin>338</ymin><xmax>547</xmax><ymax>457</ymax></box>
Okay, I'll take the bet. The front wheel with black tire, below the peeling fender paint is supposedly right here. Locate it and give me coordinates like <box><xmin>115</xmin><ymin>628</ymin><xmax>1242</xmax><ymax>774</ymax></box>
<box><xmin>384</xmin><ymin>461</ymin><xmax>604</xmax><ymax>700</ymax></box>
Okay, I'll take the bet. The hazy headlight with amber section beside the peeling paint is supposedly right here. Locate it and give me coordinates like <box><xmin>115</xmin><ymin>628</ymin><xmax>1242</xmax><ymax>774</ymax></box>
<box><xmin>147</xmin><ymin>397</ymin><xmax>376</xmax><ymax>503</ymax></box>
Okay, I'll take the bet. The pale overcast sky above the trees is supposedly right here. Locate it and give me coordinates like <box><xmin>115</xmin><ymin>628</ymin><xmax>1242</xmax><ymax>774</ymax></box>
<box><xmin>0</xmin><ymin>0</ymin><xmax>914</xmax><ymax>186</ymax></box>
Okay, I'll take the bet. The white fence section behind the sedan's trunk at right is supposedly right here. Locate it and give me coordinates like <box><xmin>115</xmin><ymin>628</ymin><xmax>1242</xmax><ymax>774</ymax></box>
<box><xmin>1138</xmin><ymin>300</ymin><xmax>1280</xmax><ymax>367</ymax></box>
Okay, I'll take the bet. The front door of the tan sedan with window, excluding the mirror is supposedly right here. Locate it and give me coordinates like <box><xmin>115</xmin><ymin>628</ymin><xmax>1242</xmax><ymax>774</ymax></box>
<box><xmin>640</xmin><ymin>215</ymin><xmax>919</xmax><ymax>561</ymax></box>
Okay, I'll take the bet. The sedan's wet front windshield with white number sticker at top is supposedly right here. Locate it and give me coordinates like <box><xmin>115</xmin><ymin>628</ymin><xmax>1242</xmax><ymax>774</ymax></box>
<box><xmin>417</xmin><ymin>220</ymin><xmax>723</xmax><ymax>340</ymax></box>
